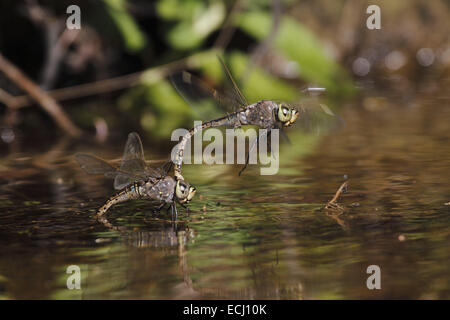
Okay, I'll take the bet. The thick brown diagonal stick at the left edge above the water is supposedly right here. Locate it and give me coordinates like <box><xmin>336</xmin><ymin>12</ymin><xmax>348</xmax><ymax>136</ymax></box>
<box><xmin>0</xmin><ymin>53</ymin><xmax>82</xmax><ymax>137</ymax></box>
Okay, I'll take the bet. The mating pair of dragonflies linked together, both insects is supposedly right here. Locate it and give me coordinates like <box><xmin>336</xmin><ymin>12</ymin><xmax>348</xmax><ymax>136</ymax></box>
<box><xmin>76</xmin><ymin>58</ymin><xmax>299</xmax><ymax>220</ymax></box>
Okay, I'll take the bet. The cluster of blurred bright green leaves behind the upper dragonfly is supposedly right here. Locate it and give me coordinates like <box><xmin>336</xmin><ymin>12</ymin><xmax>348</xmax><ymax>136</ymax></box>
<box><xmin>112</xmin><ymin>0</ymin><xmax>352</xmax><ymax>138</ymax></box>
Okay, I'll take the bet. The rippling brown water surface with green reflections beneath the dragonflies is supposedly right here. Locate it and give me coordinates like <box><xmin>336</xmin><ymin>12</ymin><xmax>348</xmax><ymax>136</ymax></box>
<box><xmin>0</xmin><ymin>94</ymin><xmax>450</xmax><ymax>299</ymax></box>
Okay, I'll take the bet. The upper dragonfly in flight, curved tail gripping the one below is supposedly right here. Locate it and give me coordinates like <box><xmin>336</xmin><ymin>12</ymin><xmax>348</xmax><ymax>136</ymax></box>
<box><xmin>171</xmin><ymin>57</ymin><xmax>299</xmax><ymax>179</ymax></box>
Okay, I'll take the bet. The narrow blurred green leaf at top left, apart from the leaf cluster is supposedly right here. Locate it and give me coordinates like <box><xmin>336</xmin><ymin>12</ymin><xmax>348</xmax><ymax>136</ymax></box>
<box><xmin>103</xmin><ymin>0</ymin><xmax>147</xmax><ymax>53</ymax></box>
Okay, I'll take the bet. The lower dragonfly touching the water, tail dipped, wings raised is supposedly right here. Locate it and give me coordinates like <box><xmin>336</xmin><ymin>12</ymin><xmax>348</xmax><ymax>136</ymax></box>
<box><xmin>75</xmin><ymin>132</ymin><xmax>196</xmax><ymax>219</ymax></box>
